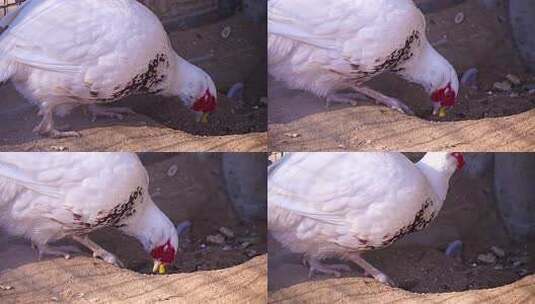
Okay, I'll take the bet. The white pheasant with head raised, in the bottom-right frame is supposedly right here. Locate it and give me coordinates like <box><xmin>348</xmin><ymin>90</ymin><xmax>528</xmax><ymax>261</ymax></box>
<box><xmin>268</xmin><ymin>153</ymin><xmax>464</xmax><ymax>285</ymax></box>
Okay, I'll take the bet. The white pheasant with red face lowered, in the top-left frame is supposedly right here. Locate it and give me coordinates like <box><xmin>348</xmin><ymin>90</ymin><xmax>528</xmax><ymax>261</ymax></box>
<box><xmin>0</xmin><ymin>0</ymin><xmax>217</xmax><ymax>137</ymax></box>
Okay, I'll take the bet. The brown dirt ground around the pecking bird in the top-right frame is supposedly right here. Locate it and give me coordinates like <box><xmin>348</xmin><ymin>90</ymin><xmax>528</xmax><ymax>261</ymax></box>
<box><xmin>268</xmin><ymin>1</ymin><xmax>535</xmax><ymax>151</ymax></box>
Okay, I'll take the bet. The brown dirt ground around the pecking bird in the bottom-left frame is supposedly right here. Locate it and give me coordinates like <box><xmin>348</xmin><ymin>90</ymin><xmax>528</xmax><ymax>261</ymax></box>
<box><xmin>0</xmin><ymin>153</ymin><xmax>267</xmax><ymax>303</ymax></box>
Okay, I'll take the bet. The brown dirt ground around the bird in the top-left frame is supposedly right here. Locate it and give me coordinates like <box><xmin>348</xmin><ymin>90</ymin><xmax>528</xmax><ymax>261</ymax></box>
<box><xmin>0</xmin><ymin>14</ymin><xmax>267</xmax><ymax>151</ymax></box>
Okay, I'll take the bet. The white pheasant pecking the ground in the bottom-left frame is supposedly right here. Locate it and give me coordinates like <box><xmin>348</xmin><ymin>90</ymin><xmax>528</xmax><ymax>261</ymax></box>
<box><xmin>0</xmin><ymin>153</ymin><xmax>178</xmax><ymax>272</ymax></box>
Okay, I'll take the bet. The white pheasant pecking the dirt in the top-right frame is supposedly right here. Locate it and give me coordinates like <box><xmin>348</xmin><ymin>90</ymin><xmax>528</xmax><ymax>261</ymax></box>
<box><xmin>268</xmin><ymin>0</ymin><xmax>459</xmax><ymax>116</ymax></box>
